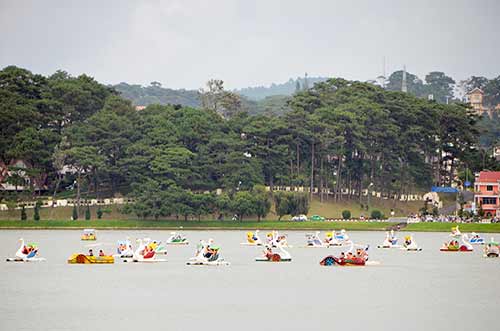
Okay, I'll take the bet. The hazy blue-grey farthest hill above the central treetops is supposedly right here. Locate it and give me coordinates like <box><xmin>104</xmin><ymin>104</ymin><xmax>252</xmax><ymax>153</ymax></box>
<box><xmin>234</xmin><ymin>77</ymin><xmax>328</xmax><ymax>100</ymax></box>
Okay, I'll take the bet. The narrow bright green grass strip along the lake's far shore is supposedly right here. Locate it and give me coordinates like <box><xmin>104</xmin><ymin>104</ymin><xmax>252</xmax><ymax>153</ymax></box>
<box><xmin>0</xmin><ymin>220</ymin><xmax>500</xmax><ymax>232</ymax></box>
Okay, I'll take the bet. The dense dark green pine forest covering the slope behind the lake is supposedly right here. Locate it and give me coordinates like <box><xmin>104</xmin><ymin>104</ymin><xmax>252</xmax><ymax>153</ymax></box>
<box><xmin>0</xmin><ymin>66</ymin><xmax>498</xmax><ymax>218</ymax></box>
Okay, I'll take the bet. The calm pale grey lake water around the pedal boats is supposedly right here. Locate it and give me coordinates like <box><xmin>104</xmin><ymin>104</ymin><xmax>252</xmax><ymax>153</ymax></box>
<box><xmin>0</xmin><ymin>230</ymin><xmax>500</xmax><ymax>331</ymax></box>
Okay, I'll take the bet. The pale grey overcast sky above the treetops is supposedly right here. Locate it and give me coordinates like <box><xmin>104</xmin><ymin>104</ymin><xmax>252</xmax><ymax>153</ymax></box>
<box><xmin>0</xmin><ymin>0</ymin><xmax>500</xmax><ymax>89</ymax></box>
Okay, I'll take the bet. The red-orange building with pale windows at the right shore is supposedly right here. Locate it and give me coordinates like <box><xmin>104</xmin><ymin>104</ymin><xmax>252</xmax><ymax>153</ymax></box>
<box><xmin>474</xmin><ymin>171</ymin><xmax>500</xmax><ymax>217</ymax></box>
